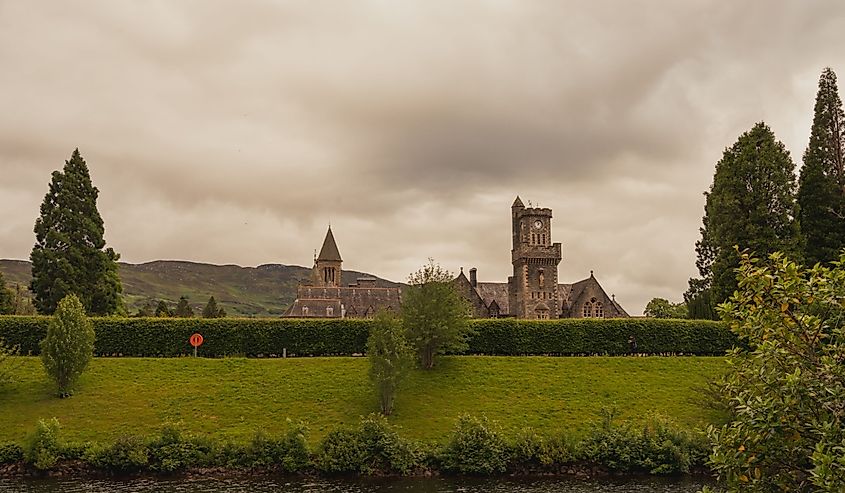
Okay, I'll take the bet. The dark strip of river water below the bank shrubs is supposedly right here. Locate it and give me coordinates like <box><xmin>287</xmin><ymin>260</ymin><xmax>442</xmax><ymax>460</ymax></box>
<box><xmin>0</xmin><ymin>477</ymin><xmax>707</xmax><ymax>493</ymax></box>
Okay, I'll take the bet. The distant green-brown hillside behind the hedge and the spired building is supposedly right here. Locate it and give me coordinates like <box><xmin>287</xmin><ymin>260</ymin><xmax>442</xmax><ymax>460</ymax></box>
<box><xmin>0</xmin><ymin>260</ymin><xmax>398</xmax><ymax>317</ymax></box>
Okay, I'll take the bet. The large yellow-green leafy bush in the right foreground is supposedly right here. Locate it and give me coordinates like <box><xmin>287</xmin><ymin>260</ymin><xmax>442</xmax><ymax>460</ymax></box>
<box><xmin>710</xmin><ymin>253</ymin><xmax>845</xmax><ymax>492</ymax></box>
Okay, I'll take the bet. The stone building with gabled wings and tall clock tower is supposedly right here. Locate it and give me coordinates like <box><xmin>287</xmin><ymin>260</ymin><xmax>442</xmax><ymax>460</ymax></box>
<box><xmin>455</xmin><ymin>197</ymin><xmax>628</xmax><ymax>319</ymax></box>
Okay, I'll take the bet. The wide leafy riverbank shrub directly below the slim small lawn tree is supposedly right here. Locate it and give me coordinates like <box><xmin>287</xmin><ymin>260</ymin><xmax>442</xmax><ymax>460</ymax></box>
<box><xmin>316</xmin><ymin>414</ymin><xmax>421</xmax><ymax>474</ymax></box>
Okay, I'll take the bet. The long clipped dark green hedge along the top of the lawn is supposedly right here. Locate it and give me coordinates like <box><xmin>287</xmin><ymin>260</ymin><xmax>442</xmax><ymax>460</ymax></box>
<box><xmin>0</xmin><ymin>316</ymin><xmax>736</xmax><ymax>357</ymax></box>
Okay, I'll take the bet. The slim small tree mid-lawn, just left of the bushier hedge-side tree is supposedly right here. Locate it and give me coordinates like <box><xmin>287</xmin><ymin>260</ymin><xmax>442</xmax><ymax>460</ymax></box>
<box><xmin>367</xmin><ymin>310</ymin><xmax>413</xmax><ymax>416</ymax></box>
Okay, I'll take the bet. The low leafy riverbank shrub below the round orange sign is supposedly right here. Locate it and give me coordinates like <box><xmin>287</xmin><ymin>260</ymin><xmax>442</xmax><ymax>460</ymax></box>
<box><xmin>147</xmin><ymin>424</ymin><xmax>214</xmax><ymax>473</ymax></box>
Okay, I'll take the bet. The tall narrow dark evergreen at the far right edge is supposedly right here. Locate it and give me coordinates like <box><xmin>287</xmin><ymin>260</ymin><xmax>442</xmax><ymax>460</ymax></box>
<box><xmin>798</xmin><ymin>68</ymin><xmax>845</xmax><ymax>265</ymax></box>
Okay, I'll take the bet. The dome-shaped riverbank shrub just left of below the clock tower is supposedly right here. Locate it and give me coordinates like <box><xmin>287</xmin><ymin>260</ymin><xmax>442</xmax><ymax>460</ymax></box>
<box><xmin>440</xmin><ymin>415</ymin><xmax>510</xmax><ymax>474</ymax></box>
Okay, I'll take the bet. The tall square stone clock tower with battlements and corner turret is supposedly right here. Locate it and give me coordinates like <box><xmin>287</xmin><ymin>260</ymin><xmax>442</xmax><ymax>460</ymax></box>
<box><xmin>508</xmin><ymin>197</ymin><xmax>562</xmax><ymax>319</ymax></box>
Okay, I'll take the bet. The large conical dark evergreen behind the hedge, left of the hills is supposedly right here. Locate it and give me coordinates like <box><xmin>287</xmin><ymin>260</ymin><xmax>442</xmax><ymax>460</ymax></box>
<box><xmin>30</xmin><ymin>149</ymin><xmax>123</xmax><ymax>315</ymax></box>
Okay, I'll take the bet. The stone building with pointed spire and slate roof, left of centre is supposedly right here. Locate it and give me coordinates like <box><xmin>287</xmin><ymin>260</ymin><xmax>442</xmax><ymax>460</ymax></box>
<box><xmin>284</xmin><ymin>227</ymin><xmax>402</xmax><ymax>318</ymax></box>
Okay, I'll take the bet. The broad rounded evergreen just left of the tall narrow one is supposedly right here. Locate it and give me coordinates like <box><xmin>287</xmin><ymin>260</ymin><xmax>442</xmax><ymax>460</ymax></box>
<box><xmin>685</xmin><ymin>122</ymin><xmax>801</xmax><ymax>308</ymax></box>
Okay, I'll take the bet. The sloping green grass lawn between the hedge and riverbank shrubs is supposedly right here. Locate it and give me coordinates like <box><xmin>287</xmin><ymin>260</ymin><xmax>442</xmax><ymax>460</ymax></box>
<box><xmin>0</xmin><ymin>356</ymin><xmax>725</xmax><ymax>441</ymax></box>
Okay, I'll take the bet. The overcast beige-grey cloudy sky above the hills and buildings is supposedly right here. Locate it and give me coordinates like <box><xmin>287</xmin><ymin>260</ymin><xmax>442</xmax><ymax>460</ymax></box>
<box><xmin>0</xmin><ymin>0</ymin><xmax>845</xmax><ymax>314</ymax></box>
